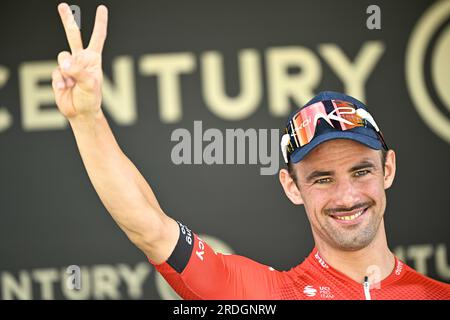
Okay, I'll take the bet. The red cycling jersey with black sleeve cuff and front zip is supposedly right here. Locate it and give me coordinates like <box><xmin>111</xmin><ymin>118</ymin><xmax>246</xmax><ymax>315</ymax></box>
<box><xmin>150</xmin><ymin>223</ymin><xmax>450</xmax><ymax>300</ymax></box>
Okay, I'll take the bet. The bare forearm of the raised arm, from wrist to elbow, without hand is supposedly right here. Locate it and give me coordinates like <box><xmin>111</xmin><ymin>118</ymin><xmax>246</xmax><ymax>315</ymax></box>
<box><xmin>69</xmin><ymin>111</ymin><xmax>164</xmax><ymax>241</ymax></box>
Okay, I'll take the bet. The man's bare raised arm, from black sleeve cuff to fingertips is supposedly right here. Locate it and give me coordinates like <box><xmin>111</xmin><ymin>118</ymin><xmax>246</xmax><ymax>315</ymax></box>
<box><xmin>52</xmin><ymin>3</ymin><xmax>179</xmax><ymax>263</ymax></box>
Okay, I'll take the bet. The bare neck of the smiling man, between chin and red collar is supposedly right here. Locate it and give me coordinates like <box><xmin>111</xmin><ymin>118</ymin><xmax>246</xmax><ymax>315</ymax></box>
<box><xmin>315</xmin><ymin>220</ymin><xmax>395</xmax><ymax>284</ymax></box>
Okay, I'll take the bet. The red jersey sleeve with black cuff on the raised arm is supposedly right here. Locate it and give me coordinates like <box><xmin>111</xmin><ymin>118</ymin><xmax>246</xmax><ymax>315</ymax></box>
<box><xmin>149</xmin><ymin>222</ymin><xmax>278</xmax><ymax>300</ymax></box>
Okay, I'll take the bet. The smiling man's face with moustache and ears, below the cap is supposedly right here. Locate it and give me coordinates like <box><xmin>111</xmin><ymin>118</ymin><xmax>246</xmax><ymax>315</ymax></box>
<box><xmin>280</xmin><ymin>139</ymin><xmax>395</xmax><ymax>251</ymax></box>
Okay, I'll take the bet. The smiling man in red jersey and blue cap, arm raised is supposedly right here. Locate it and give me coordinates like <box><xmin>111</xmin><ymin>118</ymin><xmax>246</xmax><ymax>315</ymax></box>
<box><xmin>52</xmin><ymin>4</ymin><xmax>450</xmax><ymax>299</ymax></box>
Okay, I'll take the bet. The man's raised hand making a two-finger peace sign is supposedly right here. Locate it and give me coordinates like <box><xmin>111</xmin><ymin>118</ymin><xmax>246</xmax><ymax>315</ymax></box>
<box><xmin>52</xmin><ymin>3</ymin><xmax>108</xmax><ymax>119</ymax></box>
